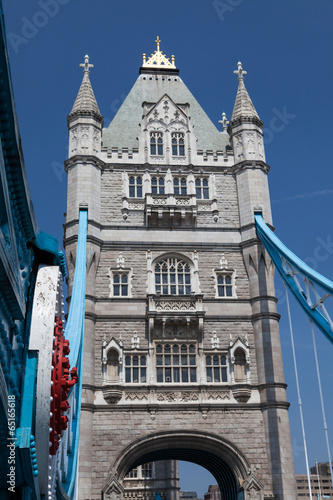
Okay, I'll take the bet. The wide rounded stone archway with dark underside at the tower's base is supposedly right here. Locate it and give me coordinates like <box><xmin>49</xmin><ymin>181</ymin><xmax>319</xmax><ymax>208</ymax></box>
<box><xmin>110</xmin><ymin>430</ymin><xmax>250</xmax><ymax>500</ymax></box>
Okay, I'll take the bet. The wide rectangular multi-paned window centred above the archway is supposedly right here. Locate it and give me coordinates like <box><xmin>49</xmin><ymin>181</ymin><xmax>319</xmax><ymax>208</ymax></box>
<box><xmin>156</xmin><ymin>344</ymin><xmax>197</xmax><ymax>384</ymax></box>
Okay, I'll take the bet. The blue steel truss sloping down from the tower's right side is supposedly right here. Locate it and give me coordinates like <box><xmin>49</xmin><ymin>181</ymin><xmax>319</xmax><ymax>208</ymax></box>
<box><xmin>254</xmin><ymin>212</ymin><xmax>333</xmax><ymax>344</ymax></box>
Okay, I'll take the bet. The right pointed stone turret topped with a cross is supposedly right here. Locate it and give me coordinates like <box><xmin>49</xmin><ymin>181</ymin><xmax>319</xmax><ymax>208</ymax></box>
<box><xmin>228</xmin><ymin>62</ymin><xmax>265</xmax><ymax>163</ymax></box>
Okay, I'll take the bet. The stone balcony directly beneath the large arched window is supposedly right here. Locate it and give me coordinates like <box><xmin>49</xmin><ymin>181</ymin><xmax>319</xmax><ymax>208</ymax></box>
<box><xmin>147</xmin><ymin>292</ymin><xmax>205</xmax><ymax>339</ymax></box>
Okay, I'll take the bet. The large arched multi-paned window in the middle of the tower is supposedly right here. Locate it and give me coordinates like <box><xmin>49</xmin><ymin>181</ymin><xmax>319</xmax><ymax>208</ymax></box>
<box><xmin>155</xmin><ymin>257</ymin><xmax>191</xmax><ymax>295</ymax></box>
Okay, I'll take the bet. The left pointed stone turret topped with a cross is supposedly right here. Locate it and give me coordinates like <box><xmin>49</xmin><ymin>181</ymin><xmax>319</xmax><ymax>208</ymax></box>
<box><xmin>67</xmin><ymin>55</ymin><xmax>103</xmax><ymax>157</ymax></box>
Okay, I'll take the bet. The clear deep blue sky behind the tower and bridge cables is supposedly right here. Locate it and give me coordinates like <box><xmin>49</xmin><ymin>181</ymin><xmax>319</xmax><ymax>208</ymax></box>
<box><xmin>3</xmin><ymin>0</ymin><xmax>333</xmax><ymax>495</ymax></box>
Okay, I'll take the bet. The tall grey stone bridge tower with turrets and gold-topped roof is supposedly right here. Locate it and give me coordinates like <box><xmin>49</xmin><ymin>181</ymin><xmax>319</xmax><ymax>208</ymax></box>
<box><xmin>65</xmin><ymin>43</ymin><xmax>296</xmax><ymax>500</ymax></box>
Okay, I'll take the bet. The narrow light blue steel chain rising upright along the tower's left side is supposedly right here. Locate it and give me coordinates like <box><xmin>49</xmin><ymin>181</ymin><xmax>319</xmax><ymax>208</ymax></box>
<box><xmin>59</xmin><ymin>210</ymin><xmax>88</xmax><ymax>499</ymax></box>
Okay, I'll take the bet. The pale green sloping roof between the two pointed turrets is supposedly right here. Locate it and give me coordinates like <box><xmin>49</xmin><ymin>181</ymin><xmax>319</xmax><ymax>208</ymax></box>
<box><xmin>102</xmin><ymin>73</ymin><xmax>229</xmax><ymax>151</ymax></box>
